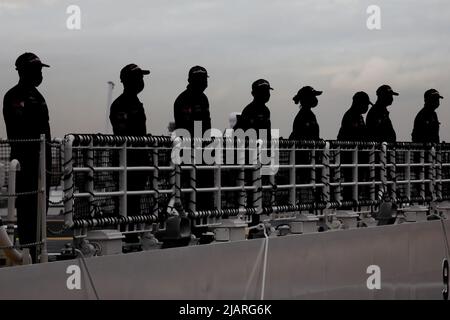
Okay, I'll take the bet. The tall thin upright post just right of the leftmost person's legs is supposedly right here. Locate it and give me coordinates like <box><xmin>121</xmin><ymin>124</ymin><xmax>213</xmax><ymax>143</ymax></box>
<box><xmin>37</xmin><ymin>134</ymin><xmax>48</xmax><ymax>263</ymax></box>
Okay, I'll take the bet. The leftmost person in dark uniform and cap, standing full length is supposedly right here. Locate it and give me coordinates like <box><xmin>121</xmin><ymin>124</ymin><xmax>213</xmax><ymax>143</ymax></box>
<box><xmin>3</xmin><ymin>52</ymin><xmax>52</xmax><ymax>262</ymax></box>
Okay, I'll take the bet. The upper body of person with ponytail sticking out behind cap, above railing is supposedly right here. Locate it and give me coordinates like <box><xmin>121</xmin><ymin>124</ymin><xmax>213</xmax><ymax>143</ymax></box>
<box><xmin>289</xmin><ymin>86</ymin><xmax>322</xmax><ymax>140</ymax></box>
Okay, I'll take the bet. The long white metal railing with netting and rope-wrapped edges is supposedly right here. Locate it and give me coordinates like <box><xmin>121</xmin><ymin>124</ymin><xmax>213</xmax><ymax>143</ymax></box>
<box><xmin>64</xmin><ymin>135</ymin><xmax>450</xmax><ymax>235</ymax></box>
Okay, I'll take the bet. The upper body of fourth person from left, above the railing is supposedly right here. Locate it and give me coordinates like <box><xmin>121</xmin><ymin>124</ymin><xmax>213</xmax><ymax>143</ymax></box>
<box><xmin>234</xmin><ymin>79</ymin><xmax>273</xmax><ymax>140</ymax></box>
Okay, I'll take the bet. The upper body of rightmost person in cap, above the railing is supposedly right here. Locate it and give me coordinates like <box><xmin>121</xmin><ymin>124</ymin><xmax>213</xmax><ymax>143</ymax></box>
<box><xmin>412</xmin><ymin>89</ymin><xmax>444</xmax><ymax>143</ymax></box>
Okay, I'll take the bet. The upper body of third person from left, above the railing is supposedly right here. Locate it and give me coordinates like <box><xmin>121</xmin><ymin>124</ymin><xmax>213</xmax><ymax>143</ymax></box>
<box><xmin>174</xmin><ymin>66</ymin><xmax>211</xmax><ymax>137</ymax></box>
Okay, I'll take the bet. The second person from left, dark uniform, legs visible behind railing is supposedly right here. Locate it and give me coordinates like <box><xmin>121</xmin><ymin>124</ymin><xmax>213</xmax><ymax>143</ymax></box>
<box><xmin>109</xmin><ymin>64</ymin><xmax>150</xmax><ymax>243</ymax></box>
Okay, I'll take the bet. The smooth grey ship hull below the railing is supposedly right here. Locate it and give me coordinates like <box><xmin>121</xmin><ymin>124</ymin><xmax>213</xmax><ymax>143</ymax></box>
<box><xmin>0</xmin><ymin>221</ymin><xmax>450</xmax><ymax>300</ymax></box>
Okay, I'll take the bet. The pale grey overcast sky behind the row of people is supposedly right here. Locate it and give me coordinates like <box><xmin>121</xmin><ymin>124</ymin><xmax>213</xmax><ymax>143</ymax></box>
<box><xmin>0</xmin><ymin>0</ymin><xmax>450</xmax><ymax>141</ymax></box>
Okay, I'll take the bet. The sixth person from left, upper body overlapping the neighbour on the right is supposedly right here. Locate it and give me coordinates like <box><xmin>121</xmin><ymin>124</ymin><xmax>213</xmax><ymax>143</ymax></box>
<box><xmin>337</xmin><ymin>91</ymin><xmax>372</xmax><ymax>141</ymax></box>
